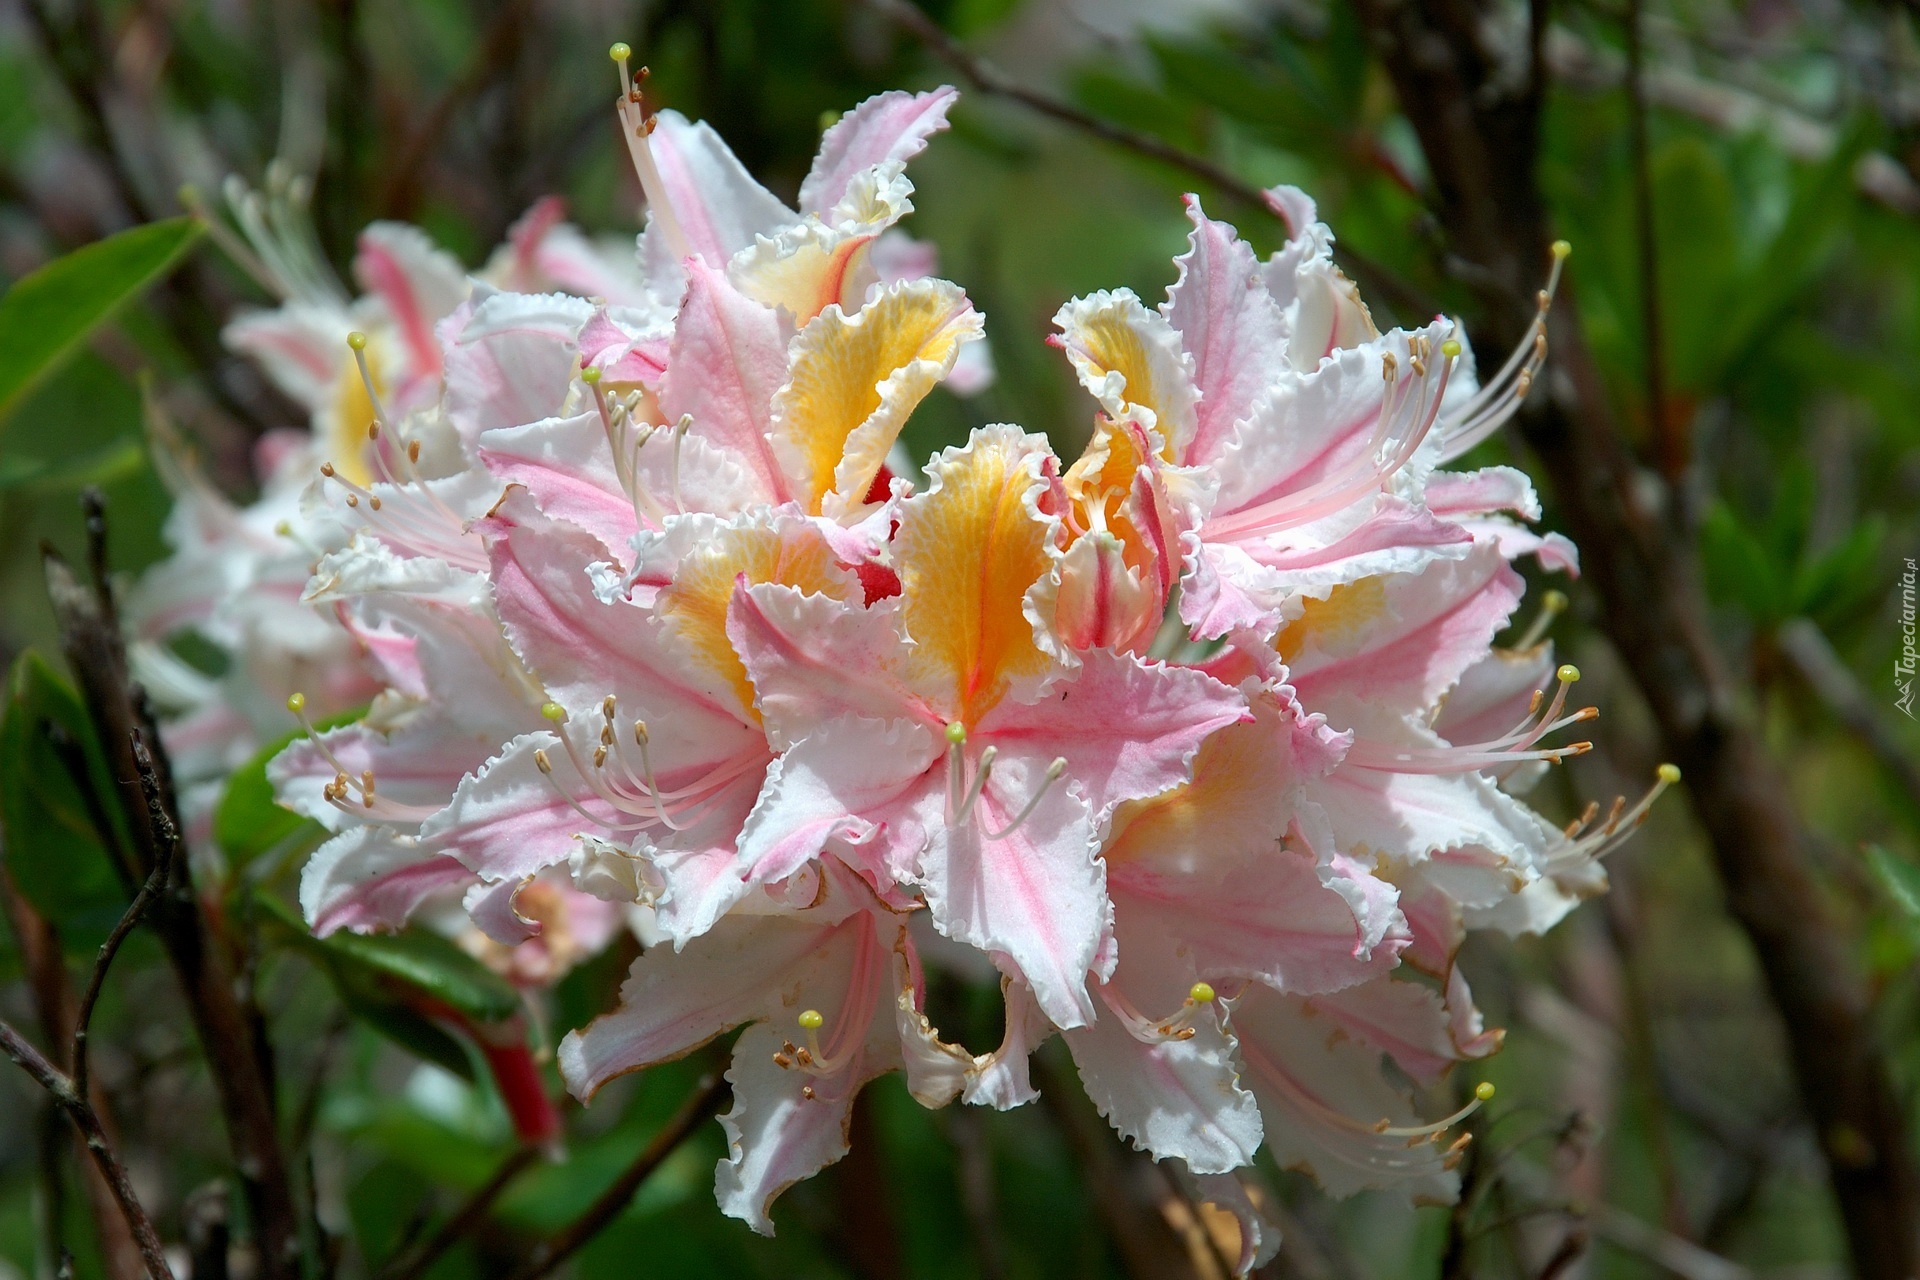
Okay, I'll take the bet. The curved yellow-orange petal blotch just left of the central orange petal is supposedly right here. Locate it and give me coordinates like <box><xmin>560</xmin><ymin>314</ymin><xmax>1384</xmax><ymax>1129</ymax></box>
<box><xmin>657</xmin><ymin>520</ymin><xmax>860</xmax><ymax>720</ymax></box>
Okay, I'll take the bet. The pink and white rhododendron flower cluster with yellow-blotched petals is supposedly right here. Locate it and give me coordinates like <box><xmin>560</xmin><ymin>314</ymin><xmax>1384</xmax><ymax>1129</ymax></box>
<box><xmin>139</xmin><ymin>46</ymin><xmax>1674</xmax><ymax>1267</ymax></box>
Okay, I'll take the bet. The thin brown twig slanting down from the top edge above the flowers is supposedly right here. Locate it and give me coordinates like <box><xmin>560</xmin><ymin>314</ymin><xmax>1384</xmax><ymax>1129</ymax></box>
<box><xmin>866</xmin><ymin>0</ymin><xmax>1436</xmax><ymax>317</ymax></box>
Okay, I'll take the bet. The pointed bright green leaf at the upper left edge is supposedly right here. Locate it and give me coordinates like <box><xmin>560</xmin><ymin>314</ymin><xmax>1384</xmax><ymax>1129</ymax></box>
<box><xmin>0</xmin><ymin>217</ymin><xmax>205</xmax><ymax>420</ymax></box>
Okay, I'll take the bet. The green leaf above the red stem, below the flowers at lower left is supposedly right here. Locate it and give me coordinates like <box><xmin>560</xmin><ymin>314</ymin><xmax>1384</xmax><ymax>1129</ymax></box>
<box><xmin>253</xmin><ymin>892</ymin><xmax>520</xmax><ymax>1080</ymax></box>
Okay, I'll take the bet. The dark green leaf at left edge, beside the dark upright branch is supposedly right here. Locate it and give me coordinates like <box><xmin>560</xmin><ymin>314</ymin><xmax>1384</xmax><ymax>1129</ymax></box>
<box><xmin>0</xmin><ymin>651</ymin><xmax>127</xmax><ymax>944</ymax></box>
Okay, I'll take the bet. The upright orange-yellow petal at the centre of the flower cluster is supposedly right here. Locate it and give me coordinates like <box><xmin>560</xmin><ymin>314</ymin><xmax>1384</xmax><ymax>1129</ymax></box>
<box><xmin>893</xmin><ymin>426</ymin><xmax>1060</xmax><ymax>725</ymax></box>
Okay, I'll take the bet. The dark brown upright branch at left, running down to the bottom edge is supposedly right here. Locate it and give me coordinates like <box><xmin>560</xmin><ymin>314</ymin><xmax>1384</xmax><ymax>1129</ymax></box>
<box><xmin>46</xmin><ymin>491</ymin><xmax>300</xmax><ymax>1280</ymax></box>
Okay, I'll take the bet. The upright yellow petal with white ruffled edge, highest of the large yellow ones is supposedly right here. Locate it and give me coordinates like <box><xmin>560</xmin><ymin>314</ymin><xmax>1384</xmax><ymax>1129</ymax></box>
<box><xmin>774</xmin><ymin>280</ymin><xmax>981</xmax><ymax>514</ymax></box>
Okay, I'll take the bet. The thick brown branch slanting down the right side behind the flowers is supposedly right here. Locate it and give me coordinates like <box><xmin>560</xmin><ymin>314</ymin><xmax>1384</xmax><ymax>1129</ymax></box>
<box><xmin>1357</xmin><ymin>0</ymin><xmax>1920</xmax><ymax>1280</ymax></box>
